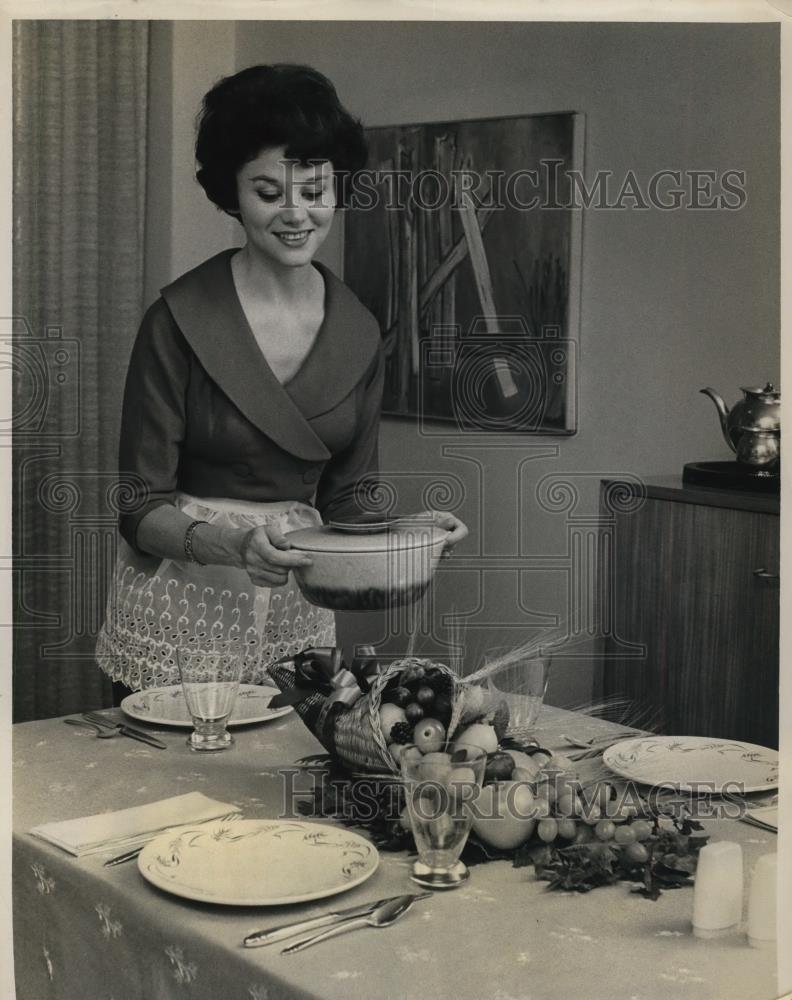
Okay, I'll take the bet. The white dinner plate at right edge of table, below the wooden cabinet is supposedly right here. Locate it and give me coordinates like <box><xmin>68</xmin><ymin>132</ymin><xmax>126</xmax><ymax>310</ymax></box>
<box><xmin>602</xmin><ymin>736</ymin><xmax>778</xmax><ymax>794</ymax></box>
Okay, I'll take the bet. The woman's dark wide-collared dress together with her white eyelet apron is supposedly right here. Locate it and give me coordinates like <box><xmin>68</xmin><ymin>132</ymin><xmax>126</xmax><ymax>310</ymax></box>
<box><xmin>97</xmin><ymin>250</ymin><xmax>384</xmax><ymax>688</ymax></box>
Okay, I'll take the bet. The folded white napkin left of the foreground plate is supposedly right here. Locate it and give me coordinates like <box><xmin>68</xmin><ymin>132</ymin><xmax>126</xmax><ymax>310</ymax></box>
<box><xmin>30</xmin><ymin>792</ymin><xmax>236</xmax><ymax>858</ymax></box>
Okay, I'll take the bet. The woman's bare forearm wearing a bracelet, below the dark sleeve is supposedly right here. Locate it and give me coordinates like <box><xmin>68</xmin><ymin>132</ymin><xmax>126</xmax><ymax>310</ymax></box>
<box><xmin>135</xmin><ymin>504</ymin><xmax>249</xmax><ymax>567</ymax></box>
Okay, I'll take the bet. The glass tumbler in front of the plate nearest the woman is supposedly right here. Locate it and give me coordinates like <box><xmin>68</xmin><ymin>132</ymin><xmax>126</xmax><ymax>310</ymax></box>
<box><xmin>176</xmin><ymin>643</ymin><xmax>244</xmax><ymax>753</ymax></box>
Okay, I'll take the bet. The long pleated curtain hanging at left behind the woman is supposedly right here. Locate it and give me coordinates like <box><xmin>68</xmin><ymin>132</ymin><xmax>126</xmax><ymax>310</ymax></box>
<box><xmin>11</xmin><ymin>20</ymin><xmax>148</xmax><ymax>721</ymax></box>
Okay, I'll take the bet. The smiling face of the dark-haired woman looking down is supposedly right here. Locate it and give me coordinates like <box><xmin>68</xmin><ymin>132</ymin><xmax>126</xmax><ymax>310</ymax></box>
<box><xmin>237</xmin><ymin>147</ymin><xmax>335</xmax><ymax>267</ymax></box>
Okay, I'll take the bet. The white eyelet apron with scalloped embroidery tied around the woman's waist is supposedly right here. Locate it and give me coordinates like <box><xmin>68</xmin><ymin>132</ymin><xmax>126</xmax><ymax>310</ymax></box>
<box><xmin>96</xmin><ymin>494</ymin><xmax>335</xmax><ymax>691</ymax></box>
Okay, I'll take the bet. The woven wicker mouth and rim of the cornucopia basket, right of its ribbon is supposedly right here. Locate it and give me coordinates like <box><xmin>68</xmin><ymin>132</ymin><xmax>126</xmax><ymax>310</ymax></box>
<box><xmin>335</xmin><ymin>657</ymin><xmax>459</xmax><ymax>772</ymax></box>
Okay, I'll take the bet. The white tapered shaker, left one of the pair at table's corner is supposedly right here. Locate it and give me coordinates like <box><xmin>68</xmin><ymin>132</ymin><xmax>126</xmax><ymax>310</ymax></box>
<box><xmin>693</xmin><ymin>840</ymin><xmax>743</xmax><ymax>938</ymax></box>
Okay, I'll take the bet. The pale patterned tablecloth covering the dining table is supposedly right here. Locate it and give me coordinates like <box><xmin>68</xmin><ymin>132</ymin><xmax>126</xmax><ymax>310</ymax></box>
<box><xmin>12</xmin><ymin>705</ymin><xmax>778</xmax><ymax>1000</ymax></box>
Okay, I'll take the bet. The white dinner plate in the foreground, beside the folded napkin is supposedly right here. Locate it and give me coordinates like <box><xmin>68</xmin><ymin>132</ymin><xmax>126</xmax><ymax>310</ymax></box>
<box><xmin>138</xmin><ymin>819</ymin><xmax>379</xmax><ymax>906</ymax></box>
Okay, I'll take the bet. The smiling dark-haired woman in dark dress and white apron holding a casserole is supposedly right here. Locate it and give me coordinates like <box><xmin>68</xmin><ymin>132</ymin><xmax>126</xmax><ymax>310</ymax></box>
<box><xmin>97</xmin><ymin>58</ymin><xmax>467</xmax><ymax>690</ymax></box>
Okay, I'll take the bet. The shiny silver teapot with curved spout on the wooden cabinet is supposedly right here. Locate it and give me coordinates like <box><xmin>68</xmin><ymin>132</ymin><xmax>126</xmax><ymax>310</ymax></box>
<box><xmin>700</xmin><ymin>382</ymin><xmax>781</xmax><ymax>475</ymax></box>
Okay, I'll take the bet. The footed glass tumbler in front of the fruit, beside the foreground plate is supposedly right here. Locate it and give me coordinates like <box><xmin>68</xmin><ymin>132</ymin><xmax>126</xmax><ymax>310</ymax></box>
<box><xmin>400</xmin><ymin>746</ymin><xmax>487</xmax><ymax>889</ymax></box>
